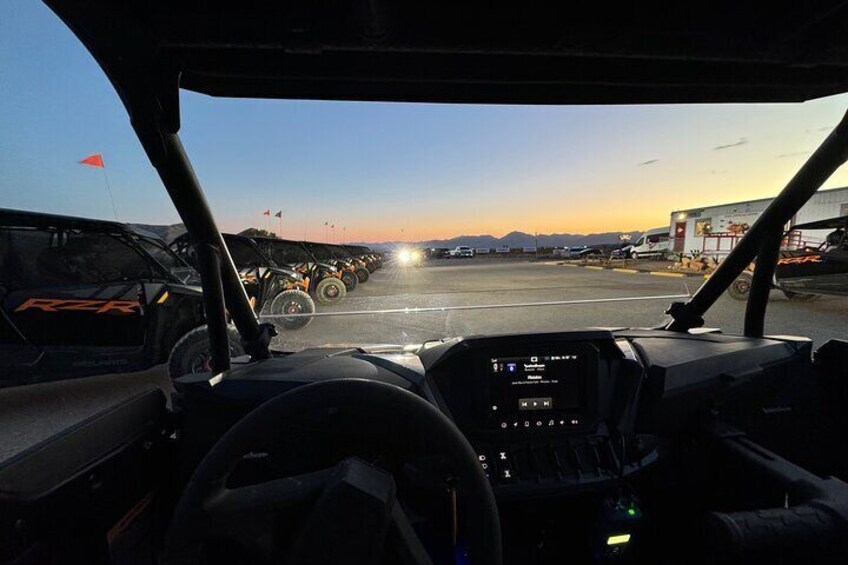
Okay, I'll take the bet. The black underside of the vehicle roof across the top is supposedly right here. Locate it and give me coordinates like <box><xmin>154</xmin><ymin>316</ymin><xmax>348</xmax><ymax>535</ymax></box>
<box><xmin>46</xmin><ymin>0</ymin><xmax>848</xmax><ymax>110</ymax></box>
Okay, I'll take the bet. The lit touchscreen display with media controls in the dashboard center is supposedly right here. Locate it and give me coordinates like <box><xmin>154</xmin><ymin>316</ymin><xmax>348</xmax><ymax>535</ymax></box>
<box><xmin>489</xmin><ymin>353</ymin><xmax>587</xmax><ymax>418</ymax></box>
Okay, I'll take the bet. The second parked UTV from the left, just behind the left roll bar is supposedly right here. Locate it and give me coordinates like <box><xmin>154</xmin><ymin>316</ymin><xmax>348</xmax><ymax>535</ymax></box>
<box><xmin>171</xmin><ymin>233</ymin><xmax>315</xmax><ymax>330</ymax></box>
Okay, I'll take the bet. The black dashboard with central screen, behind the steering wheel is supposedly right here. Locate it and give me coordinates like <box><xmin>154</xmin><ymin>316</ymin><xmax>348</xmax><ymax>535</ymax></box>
<box><xmin>176</xmin><ymin>330</ymin><xmax>811</xmax><ymax>499</ymax></box>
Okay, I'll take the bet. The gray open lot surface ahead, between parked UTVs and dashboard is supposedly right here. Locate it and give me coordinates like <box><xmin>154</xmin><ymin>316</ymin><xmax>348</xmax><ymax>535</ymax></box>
<box><xmin>274</xmin><ymin>258</ymin><xmax>848</xmax><ymax>350</ymax></box>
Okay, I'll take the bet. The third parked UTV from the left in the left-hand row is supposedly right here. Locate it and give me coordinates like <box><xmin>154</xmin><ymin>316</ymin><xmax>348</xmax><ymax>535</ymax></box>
<box><xmin>253</xmin><ymin>237</ymin><xmax>347</xmax><ymax>304</ymax></box>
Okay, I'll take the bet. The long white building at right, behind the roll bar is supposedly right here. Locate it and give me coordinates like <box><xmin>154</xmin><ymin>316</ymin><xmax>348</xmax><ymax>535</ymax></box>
<box><xmin>669</xmin><ymin>187</ymin><xmax>848</xmax><ymax>256</ymax></box>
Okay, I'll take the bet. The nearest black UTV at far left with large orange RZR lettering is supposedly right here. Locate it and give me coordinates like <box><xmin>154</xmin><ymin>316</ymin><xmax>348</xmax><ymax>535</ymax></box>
<box><xmin>0</xmin><ymin>210</ymin><xmax>244</xmax><ymax>387</ymax></box>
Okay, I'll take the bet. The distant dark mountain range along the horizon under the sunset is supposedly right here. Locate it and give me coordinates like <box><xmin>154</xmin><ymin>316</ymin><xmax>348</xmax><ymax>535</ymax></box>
<box><xmin>133</xmin><ymin>224</ymin><xmax>641</xmax><ymax>249</ymax></box>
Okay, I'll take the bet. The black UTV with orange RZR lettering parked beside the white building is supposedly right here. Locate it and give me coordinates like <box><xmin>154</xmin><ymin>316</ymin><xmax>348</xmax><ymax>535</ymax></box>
<box><xmin>727</xmin><ymin>216</ymin><xmax>848</xmax><ymax>302</ymax></box>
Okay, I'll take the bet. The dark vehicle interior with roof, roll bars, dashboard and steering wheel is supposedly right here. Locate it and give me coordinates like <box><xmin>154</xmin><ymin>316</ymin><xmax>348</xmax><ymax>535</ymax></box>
<box><xmin>0</xmin><ymin>0</ymin><xmax>848</xmax><ymax>565</ymax></box>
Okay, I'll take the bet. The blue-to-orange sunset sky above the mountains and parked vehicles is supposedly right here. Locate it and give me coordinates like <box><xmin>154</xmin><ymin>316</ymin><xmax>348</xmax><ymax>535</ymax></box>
<box><xmin>0</xmin><ymin>0</ymin><xmax>848</xmax><ymax>242</ymax></box>
